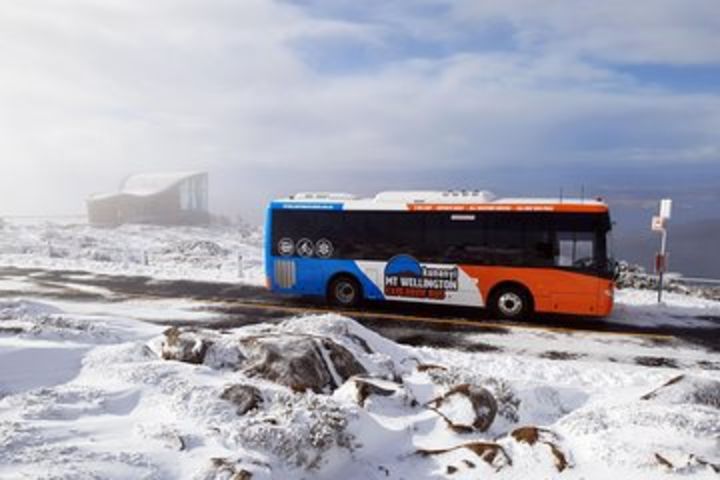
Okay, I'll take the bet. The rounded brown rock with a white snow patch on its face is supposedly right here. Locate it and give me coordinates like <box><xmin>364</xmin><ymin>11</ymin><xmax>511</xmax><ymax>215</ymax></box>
<box><xmin>428</xmin><ymin>383</ymin><xmax>498</xmax><ymax>432</ymax></box>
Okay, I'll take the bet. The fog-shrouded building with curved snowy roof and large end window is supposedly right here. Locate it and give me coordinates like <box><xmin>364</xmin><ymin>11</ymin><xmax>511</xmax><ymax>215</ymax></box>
<box><xmin>87</xmin><ymin>172</ymin><xmax>210</xmax><ymax>226</ymax></box>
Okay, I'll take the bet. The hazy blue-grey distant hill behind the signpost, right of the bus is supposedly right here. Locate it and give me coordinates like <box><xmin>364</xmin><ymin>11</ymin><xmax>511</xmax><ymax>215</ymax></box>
<box><xmin>615</xmin><ymin>218</ymin><xmax>720</xmax><ymax>278</ymax></box>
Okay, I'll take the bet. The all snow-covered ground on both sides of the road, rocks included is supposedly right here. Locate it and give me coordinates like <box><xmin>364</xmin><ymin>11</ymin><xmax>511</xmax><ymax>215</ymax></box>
<box><xmin>0</xmin><ymin>220</ymin><xmax>720</xmax><ymax>480</ymax></box>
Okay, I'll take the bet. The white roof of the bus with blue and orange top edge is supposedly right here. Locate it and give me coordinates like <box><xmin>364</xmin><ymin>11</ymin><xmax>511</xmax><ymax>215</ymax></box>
<box><xmin>271</xmin><ymin>190</ymin><xmax>608</xmax><ymax>213</ymax></box>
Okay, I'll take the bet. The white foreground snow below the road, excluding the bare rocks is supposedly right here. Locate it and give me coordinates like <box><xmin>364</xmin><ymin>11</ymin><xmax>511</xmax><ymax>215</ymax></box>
<box><xmin>0</xmin><ymin>292</ymin><xmax>720</xmax><ymax>480</ymax></box>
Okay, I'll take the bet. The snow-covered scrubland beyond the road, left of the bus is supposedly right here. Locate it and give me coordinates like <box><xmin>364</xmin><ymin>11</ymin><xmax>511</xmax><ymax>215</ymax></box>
<box><xmin>0</xmin><ymin>222</ymin><xmax>265</xmax><ymax>285</ymax></box>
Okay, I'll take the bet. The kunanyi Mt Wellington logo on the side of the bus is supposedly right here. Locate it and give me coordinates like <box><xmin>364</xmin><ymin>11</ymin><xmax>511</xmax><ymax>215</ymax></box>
<box><xmin>385</xmin><ymin>255</ymin><xmax>459</xmax><ymax>300</ymax></box>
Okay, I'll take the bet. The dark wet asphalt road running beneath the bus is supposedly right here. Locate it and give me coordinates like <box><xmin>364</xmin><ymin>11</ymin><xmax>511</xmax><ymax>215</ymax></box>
<box><xmin>0</xmin><ymin>267</ymin><xmax>720</xmax><ymax>351</ymax></box>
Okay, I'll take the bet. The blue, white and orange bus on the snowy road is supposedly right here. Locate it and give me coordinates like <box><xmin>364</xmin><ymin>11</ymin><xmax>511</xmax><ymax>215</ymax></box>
<box><xmin>265</xmin><ymin>191</ymin><xmax>614</xmax><ymax>319</ymax></box>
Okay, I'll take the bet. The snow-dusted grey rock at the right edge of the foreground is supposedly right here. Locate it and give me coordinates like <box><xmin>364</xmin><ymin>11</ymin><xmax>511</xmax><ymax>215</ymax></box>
<box><xmin>640</xmin><ymin>375</ymin><xmax>720</xmax><ymax>409</ymax></box>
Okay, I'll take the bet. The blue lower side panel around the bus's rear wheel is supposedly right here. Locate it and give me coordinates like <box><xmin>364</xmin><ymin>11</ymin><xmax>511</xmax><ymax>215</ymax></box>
<box><xmin>268</xmin><ymin>257</ymin><xmax>385</xmax><ymax>300</ymax></box>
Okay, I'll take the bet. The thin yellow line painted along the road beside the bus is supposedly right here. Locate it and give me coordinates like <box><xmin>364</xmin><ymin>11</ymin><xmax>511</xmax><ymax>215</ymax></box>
<box><xmin>212</xmin><ymin>302</ymin><xmax>675</xmax><ymax>341</ymax></box>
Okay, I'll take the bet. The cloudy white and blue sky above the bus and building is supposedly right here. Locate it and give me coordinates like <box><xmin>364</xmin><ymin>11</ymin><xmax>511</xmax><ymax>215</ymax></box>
<box><xmin>0</xmin><ymin>0</ymin><xmax>720</xmax><ymax>229</ymax></box>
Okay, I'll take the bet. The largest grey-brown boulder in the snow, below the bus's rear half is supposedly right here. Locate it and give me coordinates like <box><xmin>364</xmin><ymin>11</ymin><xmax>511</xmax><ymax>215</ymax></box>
<box><xmin>241</xmin><ymin>334</ymin><xmax>367</xmax><ymax>393</ymax></box>
